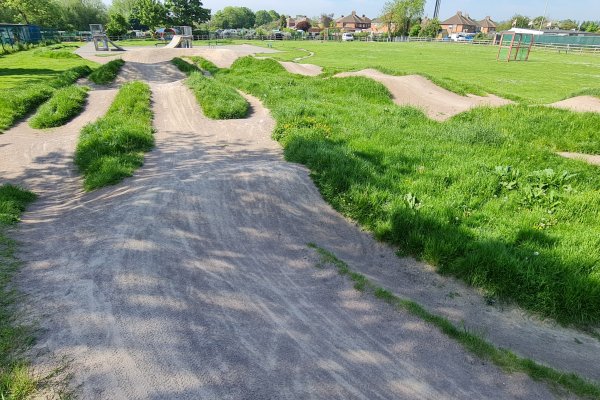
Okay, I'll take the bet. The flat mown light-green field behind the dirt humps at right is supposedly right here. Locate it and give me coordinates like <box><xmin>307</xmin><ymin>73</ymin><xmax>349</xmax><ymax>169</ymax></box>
<box><xmin>248</xmin><ymin>41</ymin><xmax>600</xmax><ymax>104</ymax></box>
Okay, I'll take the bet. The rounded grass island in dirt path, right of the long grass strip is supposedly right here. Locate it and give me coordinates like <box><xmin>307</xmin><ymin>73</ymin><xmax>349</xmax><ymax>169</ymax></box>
<box><xmin>186</xmin><ymin>72</ymin><xmax>250</xmax><ymax>119</ymax></box>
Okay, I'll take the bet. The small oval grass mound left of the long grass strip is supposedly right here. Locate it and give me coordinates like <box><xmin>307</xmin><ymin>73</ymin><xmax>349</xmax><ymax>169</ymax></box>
<box><xmin>29</xmin><ymin>85</ymin><xmax>89</xmax><ymax>129</ymax></box>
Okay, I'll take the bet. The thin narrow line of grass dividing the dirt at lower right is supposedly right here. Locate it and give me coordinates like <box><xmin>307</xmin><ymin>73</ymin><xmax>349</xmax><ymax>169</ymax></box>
<box><xmin>308</xmin><ymin>243</ymin><xmax>600</xmax><ymax>399</ymax></box>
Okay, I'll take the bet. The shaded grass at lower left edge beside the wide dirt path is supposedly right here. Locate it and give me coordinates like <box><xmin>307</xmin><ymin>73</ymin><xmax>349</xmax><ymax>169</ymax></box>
<box><xmin>0</xmin><ymin>185</ymin><xmax>36</xmax><ymax>400</ymax></box>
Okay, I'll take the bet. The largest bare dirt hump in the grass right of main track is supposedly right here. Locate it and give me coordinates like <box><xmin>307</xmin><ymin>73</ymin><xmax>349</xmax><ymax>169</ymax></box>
<box><xmin>335</xmin><ymin>69</ymin><xmax>512</xmax><ymax>121</ymax></box>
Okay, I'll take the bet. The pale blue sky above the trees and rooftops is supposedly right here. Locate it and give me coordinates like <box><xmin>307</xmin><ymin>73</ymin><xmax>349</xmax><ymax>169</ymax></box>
<box><xmin>104</xmin><ymin>0</ymin><xmax>600</xmax><ymax>21</ymax></box>
